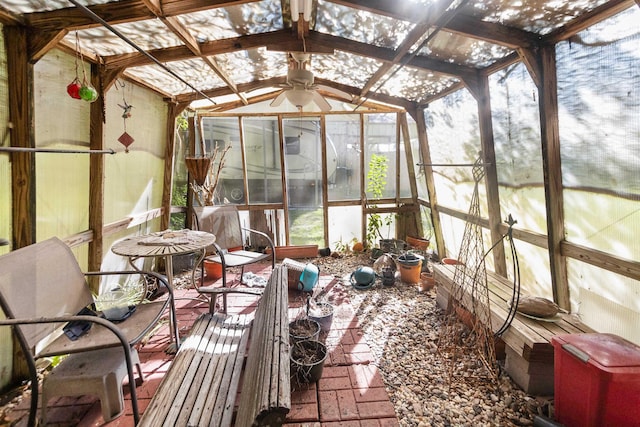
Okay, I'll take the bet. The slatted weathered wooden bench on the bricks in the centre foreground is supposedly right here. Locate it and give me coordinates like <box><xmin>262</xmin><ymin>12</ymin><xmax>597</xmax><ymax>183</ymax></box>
<box><xmin>141</xmin><ymin>265</ymin><xmax>291</xmax><ymax>427</ymax></box>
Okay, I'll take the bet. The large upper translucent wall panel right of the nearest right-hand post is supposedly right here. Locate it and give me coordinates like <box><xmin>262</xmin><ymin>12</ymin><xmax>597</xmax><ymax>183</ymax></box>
<box><xmin>556</xmin><ymin>7</ymin><xmax>640</xmax><ymax>259</ymax></box>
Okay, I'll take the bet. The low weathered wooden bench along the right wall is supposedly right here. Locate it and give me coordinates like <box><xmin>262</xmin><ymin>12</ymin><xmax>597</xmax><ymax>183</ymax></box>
<box><xmin>433</xmin><ymin>264</ymin><xmax>594</xmax><ymax>395</ymax></box>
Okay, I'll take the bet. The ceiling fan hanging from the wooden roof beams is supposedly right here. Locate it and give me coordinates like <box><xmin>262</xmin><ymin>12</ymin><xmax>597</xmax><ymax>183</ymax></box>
<box><xmin>270</xmin><ymin>52</ymin><xmax>350</xmax><ymax>111</ymax></box>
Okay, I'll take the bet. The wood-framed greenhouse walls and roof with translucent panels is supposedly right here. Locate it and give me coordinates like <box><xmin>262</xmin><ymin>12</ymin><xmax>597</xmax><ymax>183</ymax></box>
<box><xmin>0</xmin><ymin>0</ymin><xmax>640</xmax><ymax>424</ymax></box>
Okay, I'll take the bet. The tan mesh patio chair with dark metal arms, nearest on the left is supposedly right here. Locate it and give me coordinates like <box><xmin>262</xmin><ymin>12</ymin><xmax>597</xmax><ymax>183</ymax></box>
<box><xmin>0</xmin><ymin>238</ymin><xmax>173</xmax><ymax>425</ymax></box>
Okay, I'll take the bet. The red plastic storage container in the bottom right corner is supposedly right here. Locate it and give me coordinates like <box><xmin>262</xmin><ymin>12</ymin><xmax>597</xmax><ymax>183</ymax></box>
<box><xmin>551</xmin><ymin>334</ymin><xmax>640</xmax><ymax>427</ymax></box>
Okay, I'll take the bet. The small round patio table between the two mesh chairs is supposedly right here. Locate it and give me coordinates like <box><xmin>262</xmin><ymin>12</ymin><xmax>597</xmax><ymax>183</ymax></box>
<box><xmin>111</xmin><ymin>230</ymin><xmax>216</xmax><ymax>352</ymax></box>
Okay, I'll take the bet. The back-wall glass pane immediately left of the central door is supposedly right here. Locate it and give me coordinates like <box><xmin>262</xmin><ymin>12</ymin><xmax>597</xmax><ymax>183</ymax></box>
<box><xmin>242</xmin><ymin>117</ymin><xmax>282</xmax><ymax>203</ymax></box>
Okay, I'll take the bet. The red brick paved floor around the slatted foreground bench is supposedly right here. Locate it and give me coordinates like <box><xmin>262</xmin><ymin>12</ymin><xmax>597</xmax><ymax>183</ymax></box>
<box><xmin>10</xmin><ymin>269</ymin><xmax>399</xmax><ymax>427</ymax></box>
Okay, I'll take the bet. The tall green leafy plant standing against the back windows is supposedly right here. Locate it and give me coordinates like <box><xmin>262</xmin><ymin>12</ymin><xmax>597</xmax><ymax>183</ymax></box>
<box><xmin>366</xmin><ymin>153</ymin><xmax>393</xmax><ymax>248</ymax></box>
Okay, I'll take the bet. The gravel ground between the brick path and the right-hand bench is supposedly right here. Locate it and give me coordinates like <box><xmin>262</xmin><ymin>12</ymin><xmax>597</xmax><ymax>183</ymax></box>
<box><xmin>313</xmin><ymin>255</ymin><xmax>551</xmax><ymax>427</ymax></box>
